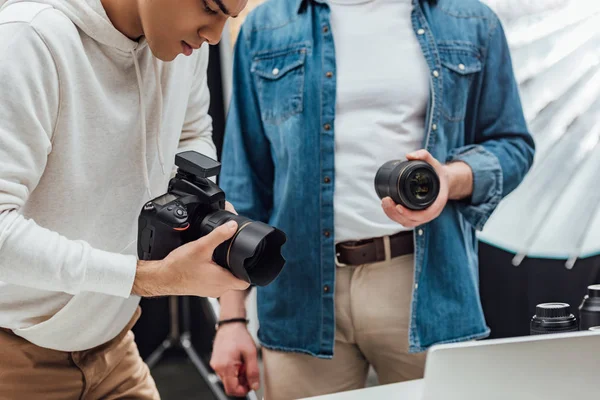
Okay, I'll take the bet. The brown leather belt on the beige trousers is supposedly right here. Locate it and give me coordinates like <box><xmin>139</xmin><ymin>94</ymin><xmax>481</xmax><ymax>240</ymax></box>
<box><xmin>335</xmin><ymin>231</ymin><xmax>414</xmax><ymax>266</ymax></box>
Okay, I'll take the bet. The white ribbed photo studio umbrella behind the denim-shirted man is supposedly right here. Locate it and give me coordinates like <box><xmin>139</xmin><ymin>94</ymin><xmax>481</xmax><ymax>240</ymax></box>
<box><xmin>479</xmin><ymin>5</ymin><xmax>600</xmax><ymax>268</ymax></box>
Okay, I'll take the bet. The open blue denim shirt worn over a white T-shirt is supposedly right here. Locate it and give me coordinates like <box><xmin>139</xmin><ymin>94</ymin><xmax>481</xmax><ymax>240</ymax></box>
<box><xmin>221</xmin><ymin>0</ymin><xmax>534</xmax><ymax>358</ymax></box>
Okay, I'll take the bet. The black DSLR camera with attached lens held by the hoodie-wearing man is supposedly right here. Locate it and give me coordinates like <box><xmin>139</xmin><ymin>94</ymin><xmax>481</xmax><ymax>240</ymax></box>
<box><xmin>138</xmin><ymin>151</ymin><xmax>286</xmax><ymax>286</ymax></box>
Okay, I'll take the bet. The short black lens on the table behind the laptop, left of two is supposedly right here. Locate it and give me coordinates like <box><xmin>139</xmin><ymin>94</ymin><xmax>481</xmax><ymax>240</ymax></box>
<box><xmin>530</xmin><ymin>303</ymin><xmax>579</xmax><ymax>335</ymax></box>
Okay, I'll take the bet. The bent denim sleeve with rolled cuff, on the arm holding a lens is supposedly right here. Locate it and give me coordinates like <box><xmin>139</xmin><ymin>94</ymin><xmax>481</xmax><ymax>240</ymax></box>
<box><xmin>447</xmin><ymin>21</ymin><xmax>534</xmax><ymax>230</ymax></box>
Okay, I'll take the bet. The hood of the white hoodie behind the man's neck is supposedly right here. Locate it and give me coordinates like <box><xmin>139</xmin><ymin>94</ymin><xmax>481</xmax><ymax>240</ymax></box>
<box><xmin>0</xmin><ymin>0</ymin><xmax>138</xmax><ymax>52</ymax></box>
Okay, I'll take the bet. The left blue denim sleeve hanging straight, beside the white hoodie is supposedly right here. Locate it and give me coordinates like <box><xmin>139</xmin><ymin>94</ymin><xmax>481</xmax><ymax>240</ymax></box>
<box><xmin>220</xmin><ymin>23</ymin><xmax>274</xmax><ymax>222</ymax></box>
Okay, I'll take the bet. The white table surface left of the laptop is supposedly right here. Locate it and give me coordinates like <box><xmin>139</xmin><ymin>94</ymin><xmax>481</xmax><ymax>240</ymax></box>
<box><xmin>302</xmin><ymin>379</ymin><xmax>423</xmax><ymax>400</ymax></box>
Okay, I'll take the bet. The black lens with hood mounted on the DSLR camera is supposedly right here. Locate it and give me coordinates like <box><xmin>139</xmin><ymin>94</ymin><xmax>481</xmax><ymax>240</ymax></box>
<box><xmin>200</xmin><ymin>210</ymin><xmax>286</xmax><ymax>286</ymax></box>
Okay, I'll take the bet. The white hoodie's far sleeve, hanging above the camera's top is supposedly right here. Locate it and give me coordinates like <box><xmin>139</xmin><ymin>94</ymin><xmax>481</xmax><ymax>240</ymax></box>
<box><xmin>178</xmin><ymin>44</ymin><xmax>217</xmax><ymax>160</ymax></box>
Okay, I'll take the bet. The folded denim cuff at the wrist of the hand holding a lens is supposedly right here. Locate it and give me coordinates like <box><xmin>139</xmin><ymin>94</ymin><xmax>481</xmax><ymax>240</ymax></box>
<box><xmin>447</xmin><ymin>145</ymin><xmax>503</xmax><ymax>230</ymax></box>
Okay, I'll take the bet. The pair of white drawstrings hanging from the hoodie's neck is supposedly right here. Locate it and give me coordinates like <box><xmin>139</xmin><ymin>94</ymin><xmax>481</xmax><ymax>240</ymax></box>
<box><xmin>131</xmin><ymin>50</ymin><xmax>166</xmax><ymax>198</ymax></box>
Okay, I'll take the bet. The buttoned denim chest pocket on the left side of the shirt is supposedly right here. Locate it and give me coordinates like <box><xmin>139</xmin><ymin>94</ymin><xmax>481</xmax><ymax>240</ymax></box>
<box><xmin>252</xmin><ymin>47</ymin><xmax>306</xmax><ymax>125</ymax></box>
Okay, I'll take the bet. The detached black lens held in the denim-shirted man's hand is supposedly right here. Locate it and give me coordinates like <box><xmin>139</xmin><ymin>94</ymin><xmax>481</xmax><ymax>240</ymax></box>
<box><xmin>375</xmin><ymin>160</ymin><xmax>440</xmax><ymax>210</ymax></box>
